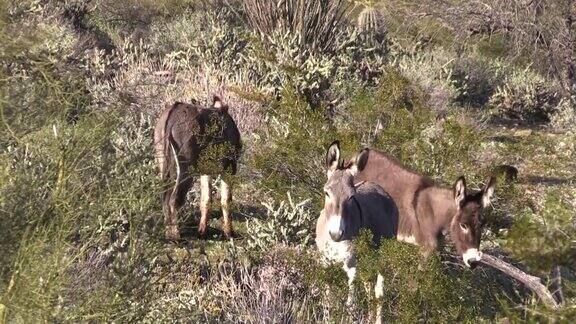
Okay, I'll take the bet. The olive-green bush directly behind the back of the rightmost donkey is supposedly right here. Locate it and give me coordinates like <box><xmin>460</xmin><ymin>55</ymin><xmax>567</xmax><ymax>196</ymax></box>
<box><xmin>335</xmin><ymin>69</ymin><xmax>483</xmax><ymax>183</ymax></box>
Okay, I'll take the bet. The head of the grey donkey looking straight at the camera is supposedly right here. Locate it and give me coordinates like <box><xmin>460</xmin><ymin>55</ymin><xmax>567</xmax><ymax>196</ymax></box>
<box><xmin>323</xmin><ymin>141</ymin><xmax>368</xmax><ymax>242</ymax></box>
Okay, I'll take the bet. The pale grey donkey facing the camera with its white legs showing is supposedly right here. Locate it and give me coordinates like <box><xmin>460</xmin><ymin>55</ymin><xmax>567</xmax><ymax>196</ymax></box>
<box><xmin>316</xmin><ymin>141</ymin><xmax>398</xmax><ymax>302</ymax></box>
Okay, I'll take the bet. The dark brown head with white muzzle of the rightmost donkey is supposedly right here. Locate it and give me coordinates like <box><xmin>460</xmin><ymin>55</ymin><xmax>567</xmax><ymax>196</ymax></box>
<box><xmin>450</xmin><ymin>177</ymin><xmax>496</xmax><ymax>267</ymax></box>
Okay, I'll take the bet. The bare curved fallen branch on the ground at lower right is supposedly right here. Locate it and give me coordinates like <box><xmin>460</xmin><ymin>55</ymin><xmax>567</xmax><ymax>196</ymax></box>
<box><xmin>480</xmin><ymin>253</ymin><xmax>559</xmax><ymax>309</ymax></box>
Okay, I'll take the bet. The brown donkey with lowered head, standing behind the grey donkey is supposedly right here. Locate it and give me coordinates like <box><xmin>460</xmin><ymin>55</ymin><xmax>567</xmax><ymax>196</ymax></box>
<box><xmin>354</xmin><ymin>148</ymin><xmax>496</xmax><ymax>266</ymax></box>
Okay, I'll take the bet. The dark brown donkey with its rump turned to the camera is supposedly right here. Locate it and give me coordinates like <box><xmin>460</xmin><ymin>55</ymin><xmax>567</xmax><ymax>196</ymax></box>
<box><xmin>154</xmin><ymin>96</ymin><xmax>242</xmax><ymax>240</ymax></box>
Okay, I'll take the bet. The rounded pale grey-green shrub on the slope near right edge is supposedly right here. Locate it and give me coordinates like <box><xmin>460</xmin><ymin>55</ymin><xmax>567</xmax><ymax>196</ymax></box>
<box><xmin>490</xmin><ymin>68</ymin><xmax>560</xmax><ymax>121</ymax></box>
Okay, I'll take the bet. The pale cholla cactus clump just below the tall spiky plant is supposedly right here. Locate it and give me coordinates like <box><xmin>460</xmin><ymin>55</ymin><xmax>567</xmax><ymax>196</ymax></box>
<box><xmin>243</xmin><ymin>29</ymin><xmax>385</xmax><ymax>108</ymax></box>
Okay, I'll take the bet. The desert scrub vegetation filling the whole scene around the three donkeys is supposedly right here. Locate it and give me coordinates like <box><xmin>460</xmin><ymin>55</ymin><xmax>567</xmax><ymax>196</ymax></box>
<box><xmin>0</xmin><ymin>0</ymin><xmax>576</xmax><ymax>323</ymax></box>
